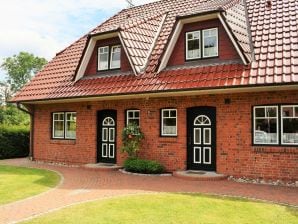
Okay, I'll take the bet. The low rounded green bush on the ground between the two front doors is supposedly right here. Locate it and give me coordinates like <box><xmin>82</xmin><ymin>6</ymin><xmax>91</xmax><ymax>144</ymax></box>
<box><xmin>124</xmin><ymin>159</ymin><xmax>165</xmax><ymax>174</ymax></box>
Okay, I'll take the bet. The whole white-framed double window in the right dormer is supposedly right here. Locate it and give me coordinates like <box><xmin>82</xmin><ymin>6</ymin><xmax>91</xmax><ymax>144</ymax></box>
<box><xmin>185</xmin><ymin>28</ymin><xmax>218</xmax><ymax>60</ymax></box>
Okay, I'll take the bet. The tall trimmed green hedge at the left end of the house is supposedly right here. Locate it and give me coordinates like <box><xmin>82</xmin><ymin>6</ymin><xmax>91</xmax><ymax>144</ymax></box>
<box><xmin>0</xmin><ymin>125</ymin><xmax>30</xmax><ymax>159</ymax></box>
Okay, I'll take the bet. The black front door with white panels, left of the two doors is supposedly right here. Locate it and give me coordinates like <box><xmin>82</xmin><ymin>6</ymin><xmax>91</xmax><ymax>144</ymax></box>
<box><xmin>97</xmin><ymin>110</ymin><xmax>117</xmax><ymax>163</ymax></box>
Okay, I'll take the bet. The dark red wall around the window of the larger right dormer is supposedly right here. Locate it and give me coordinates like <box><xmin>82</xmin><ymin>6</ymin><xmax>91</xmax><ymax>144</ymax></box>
<box><xmin>168</xmin><ymin>19</ymin><xmax>239</xmax><ymax>66</ymax></box>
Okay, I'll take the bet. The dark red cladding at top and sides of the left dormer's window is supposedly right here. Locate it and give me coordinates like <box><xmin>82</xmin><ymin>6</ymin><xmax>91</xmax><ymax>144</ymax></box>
<box><xmin>85</xmin><ymin>37</ymin><xmax>132</xmax><ymax>76</ymax></box>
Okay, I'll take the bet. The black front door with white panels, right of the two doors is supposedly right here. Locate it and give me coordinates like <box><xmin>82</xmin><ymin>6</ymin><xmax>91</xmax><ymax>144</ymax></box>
<box><xmin>187</xmin><ymin>107</ymin><xmax>216</xmax><ymax>171</ymax></box>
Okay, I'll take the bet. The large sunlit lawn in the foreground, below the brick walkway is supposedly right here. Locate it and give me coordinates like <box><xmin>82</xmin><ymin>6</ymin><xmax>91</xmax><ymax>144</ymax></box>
<box><xmin>24</xmin><ymin>194</ymin><xmax>298</xmax><ymax>224</ymax></box>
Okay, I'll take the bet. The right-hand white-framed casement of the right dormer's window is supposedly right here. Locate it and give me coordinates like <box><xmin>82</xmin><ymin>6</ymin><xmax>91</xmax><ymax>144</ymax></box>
<box><xmin>202</xmin><ymin>28</ymin><xmax>218</xmax><ymax>58</ymax></box>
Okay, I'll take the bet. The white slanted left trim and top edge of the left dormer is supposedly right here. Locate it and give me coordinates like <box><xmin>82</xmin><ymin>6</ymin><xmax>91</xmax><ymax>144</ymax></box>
<box><xmin>75</xmin><ymin>32</ymin><xmax>118</xmax><ymax>82</ymax></box>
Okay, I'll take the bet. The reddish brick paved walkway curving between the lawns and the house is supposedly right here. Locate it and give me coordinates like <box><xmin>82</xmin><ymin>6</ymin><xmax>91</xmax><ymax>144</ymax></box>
<box><xmin>0</xmin><ymin>159</ymin><xmax>298</xmax><ymax>224</ymax></box>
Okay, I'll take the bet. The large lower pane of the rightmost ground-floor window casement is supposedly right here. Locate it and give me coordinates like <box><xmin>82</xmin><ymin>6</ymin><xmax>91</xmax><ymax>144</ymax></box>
<box><xmin>282</xmin><ymin>118</ymin><xmax>298</xmax><ymax>144</ymax></box>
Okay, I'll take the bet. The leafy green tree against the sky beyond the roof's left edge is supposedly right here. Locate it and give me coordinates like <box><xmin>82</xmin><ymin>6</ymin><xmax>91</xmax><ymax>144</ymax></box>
<box><xmin>1</xmin><ymin>52</ymin><xmax>47</xmax><ymax>93</ymax></box>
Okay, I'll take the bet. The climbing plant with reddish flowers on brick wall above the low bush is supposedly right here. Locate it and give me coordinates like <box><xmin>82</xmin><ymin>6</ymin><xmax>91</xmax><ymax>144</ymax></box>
<box><xmin>121</xmin><ymin>123</ymin><xmax>144</xmax><ymax>159</ymax></box>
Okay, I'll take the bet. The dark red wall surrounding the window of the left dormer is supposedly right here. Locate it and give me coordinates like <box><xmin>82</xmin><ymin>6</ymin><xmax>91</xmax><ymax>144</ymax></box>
<box><xmin>84</xmin><ymin>37</ymin><xmax>132</xmax><ymax>76</ymax></box>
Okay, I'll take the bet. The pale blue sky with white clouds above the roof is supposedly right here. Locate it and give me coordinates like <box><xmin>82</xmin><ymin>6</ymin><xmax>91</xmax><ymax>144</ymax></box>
<box><xmin>0</xmin><ymin>0</ymin><xmax>154</xmax><ymax>81</ymax></box>
